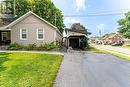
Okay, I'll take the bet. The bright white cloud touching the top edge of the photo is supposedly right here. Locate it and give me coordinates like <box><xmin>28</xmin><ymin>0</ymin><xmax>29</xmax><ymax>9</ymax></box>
<box><xmin>74</xmin><ymin>0</ymin><xmax>86</xmax><ymax>11</ymax></box>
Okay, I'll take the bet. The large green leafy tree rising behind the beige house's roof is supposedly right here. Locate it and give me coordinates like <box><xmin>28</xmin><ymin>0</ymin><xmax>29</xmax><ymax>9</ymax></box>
<box><xmin>12</xmin><ymin>0</ymin><xmax>64</xmax><ymax>32</ymax></box>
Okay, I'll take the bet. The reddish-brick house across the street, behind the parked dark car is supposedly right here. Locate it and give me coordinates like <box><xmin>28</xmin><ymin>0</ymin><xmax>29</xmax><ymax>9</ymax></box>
<box><xmin>103</xmin><ymin>34</ymin><xmax>123</xmax><ymax>44</ymax></box>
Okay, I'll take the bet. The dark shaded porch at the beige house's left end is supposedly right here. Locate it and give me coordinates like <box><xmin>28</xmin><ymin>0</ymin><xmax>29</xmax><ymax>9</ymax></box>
<box><xmin>0</xmin><ymin>30</ymin><xmax>11</xmax><ymax>45</ymax></box>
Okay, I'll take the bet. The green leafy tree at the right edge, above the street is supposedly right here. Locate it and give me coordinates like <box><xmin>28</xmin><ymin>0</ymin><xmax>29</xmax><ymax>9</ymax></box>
<box><xmin>118</xmin><ymin>12</ymin><xmax>130</xmax><ymax>39</ymax></box>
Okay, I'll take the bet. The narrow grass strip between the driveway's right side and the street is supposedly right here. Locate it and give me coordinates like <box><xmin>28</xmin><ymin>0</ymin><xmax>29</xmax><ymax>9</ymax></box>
<box><xmin>89</xmin><ymin>47</ymin><xmax>130</xmax><ymax>60</ymax></box>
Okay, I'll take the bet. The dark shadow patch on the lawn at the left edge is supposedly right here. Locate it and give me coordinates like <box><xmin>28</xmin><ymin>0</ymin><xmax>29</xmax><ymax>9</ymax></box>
<box><xmin>0</xmin><ymin>52</ymin><xmax>11</xmax><ymax>72</ymax></box>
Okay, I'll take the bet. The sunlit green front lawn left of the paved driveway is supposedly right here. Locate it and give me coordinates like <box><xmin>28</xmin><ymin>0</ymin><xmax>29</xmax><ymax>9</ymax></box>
<box><xmin>0</xmin><ymin>52</ymin><xmax>63</xmax><ymax>87</ymax></box>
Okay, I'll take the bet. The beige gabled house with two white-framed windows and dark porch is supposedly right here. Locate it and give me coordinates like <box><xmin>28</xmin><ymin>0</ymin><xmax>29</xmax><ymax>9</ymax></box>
<box><xmin>0</xmin><ymin>11</ymin><xmax>62</xmax><ymax>45</ymax></box>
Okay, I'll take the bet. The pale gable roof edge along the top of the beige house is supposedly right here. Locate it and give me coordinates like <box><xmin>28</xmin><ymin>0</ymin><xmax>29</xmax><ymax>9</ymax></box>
<box><xmin>2</xmin><ymin>11</ymin><xmax>62</xmax><ymax>35</ymax></box>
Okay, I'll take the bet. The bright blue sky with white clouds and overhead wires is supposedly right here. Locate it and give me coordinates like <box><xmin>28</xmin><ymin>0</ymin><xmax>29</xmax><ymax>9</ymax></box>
<box><xmin>52</xmin><ymin>0</ymin><xmax>130</xmax><ymax>36</ymax></box>
